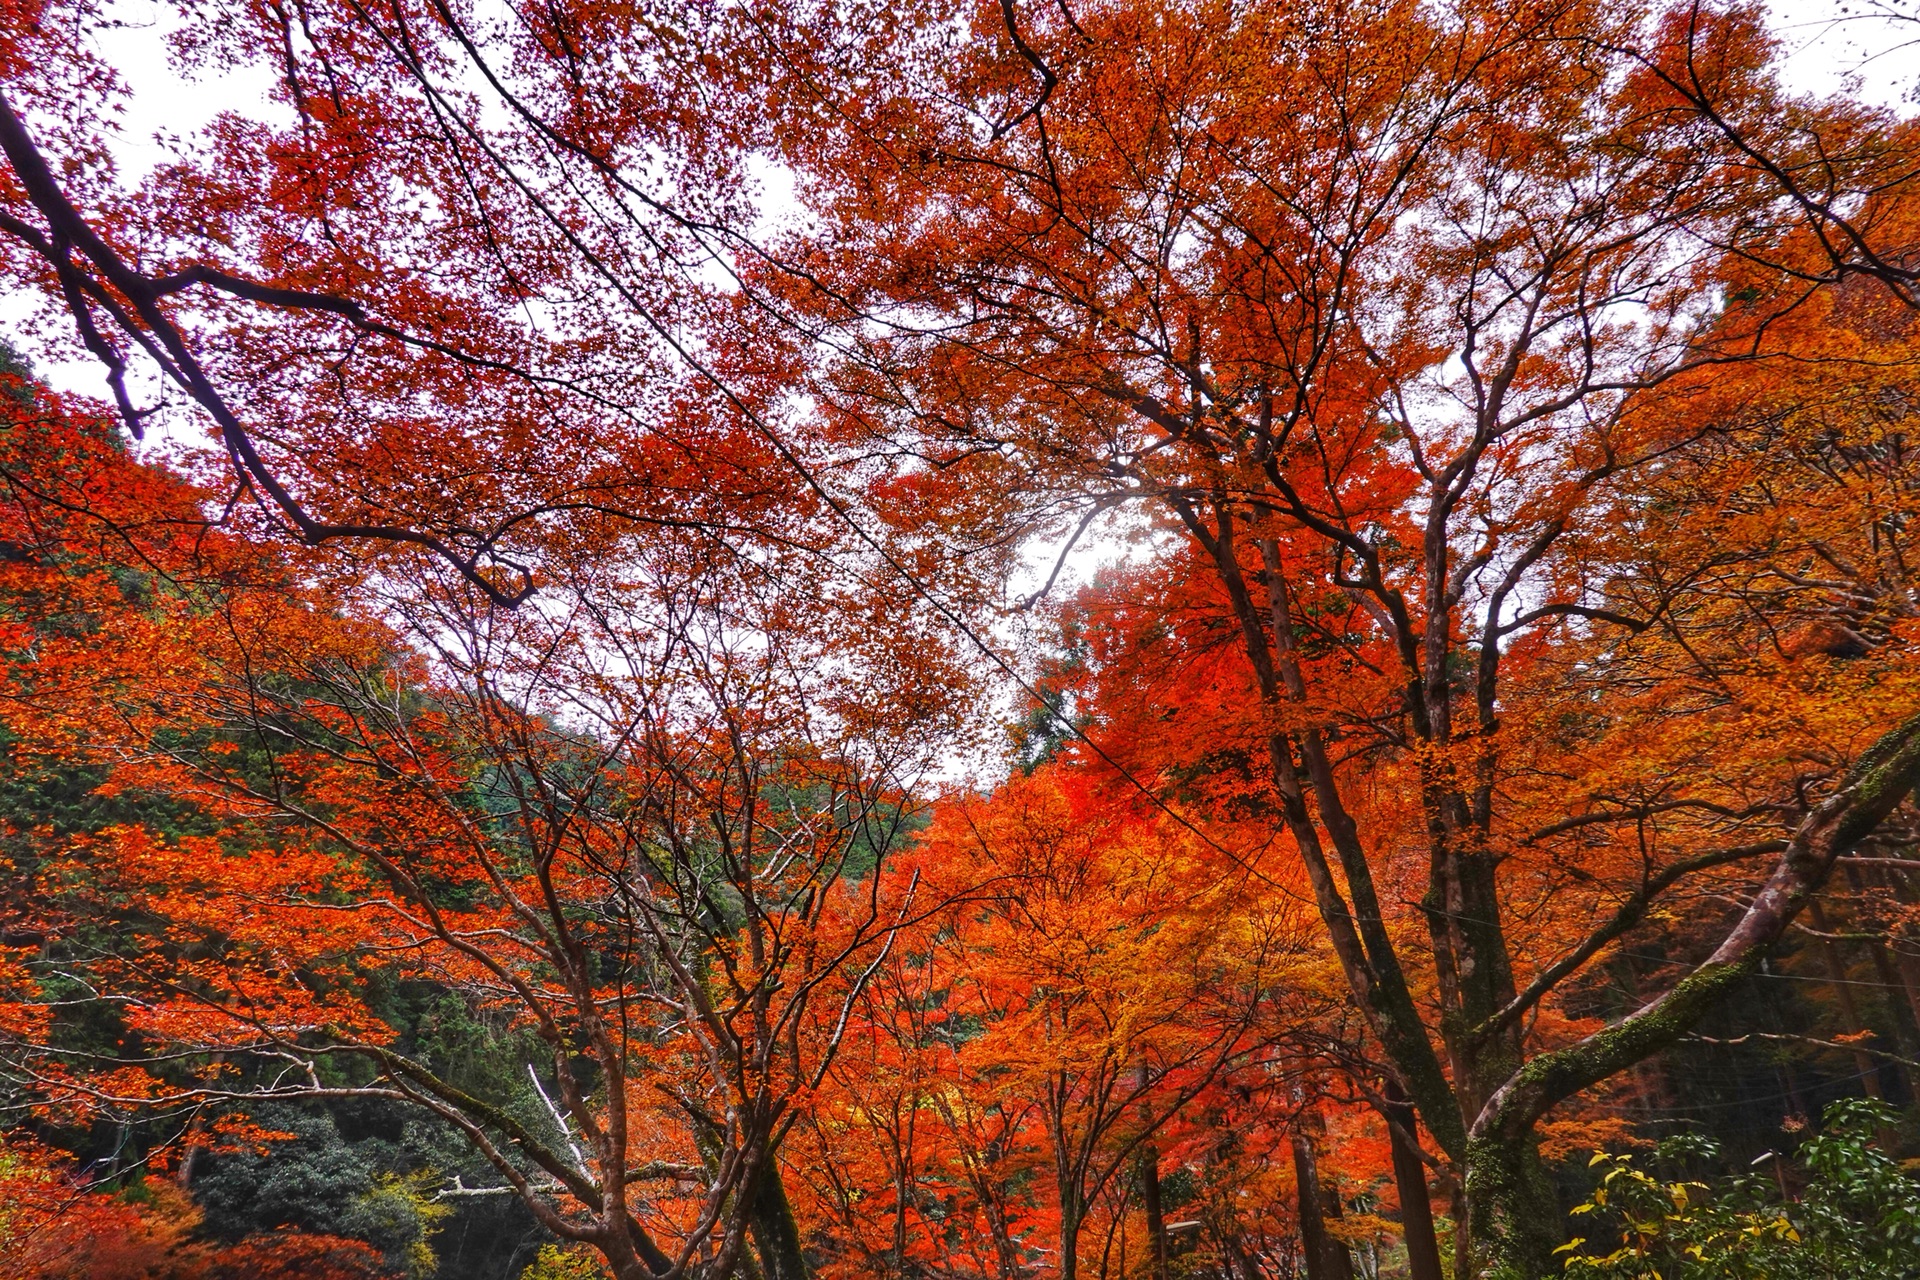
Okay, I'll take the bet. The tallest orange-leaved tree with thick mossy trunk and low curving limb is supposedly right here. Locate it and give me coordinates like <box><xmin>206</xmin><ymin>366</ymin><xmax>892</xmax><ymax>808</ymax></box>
<box><xmin>737</xmin><ymin>4</ymin><xmax>1920</xmax><ymax>1274</ymax></box>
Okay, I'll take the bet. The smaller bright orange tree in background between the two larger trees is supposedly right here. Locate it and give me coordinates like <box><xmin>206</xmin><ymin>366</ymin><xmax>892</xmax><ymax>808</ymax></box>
<box><xmin>799</xmin><ymin>762</ymin><xmax>1340</xmax><ymax>1276</ymax></box>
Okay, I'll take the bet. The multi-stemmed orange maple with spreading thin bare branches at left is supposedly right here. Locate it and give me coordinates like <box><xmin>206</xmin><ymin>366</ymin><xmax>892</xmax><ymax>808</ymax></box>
<box><xmin>4</xmin><ymin>333</ymin><xmax>975</xmax><ymax>1276</ymax></box>
